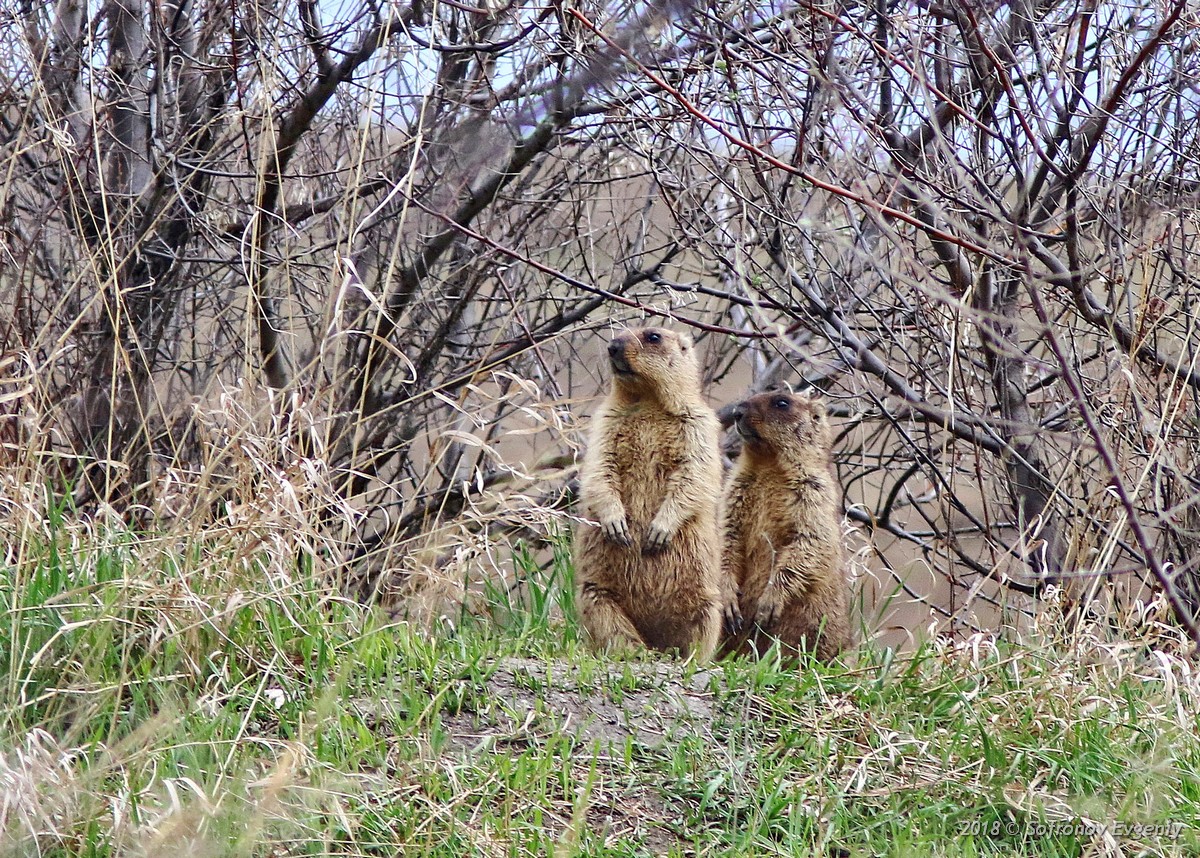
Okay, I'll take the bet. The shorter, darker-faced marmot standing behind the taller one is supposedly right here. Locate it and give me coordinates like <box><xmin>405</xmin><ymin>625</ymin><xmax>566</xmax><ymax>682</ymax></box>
<box><xmin>722</xmin><ymin>392</ymin><xmax>851</xmax><ymax>661</ymax></box>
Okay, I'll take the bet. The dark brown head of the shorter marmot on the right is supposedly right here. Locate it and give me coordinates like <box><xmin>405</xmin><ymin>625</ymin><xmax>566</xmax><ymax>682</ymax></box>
<box><xmin>733</xmin><ymin>392</ymin><xmax>833</xmax><ymax>461</ymax></box>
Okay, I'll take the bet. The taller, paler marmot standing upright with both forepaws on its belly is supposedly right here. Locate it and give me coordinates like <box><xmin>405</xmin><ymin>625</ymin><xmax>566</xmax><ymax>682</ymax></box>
<box><xmin>575</xmin><ymin>328</ymin><xmax>734</xmax><ymax>659</ymax></box>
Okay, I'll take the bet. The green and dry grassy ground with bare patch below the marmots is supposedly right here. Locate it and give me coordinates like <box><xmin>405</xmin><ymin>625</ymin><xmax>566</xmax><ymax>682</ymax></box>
<box><xmin>0</xmin><ymin>521</ymin><xmax>1200</xmax><ymax>856</ymax></box>
